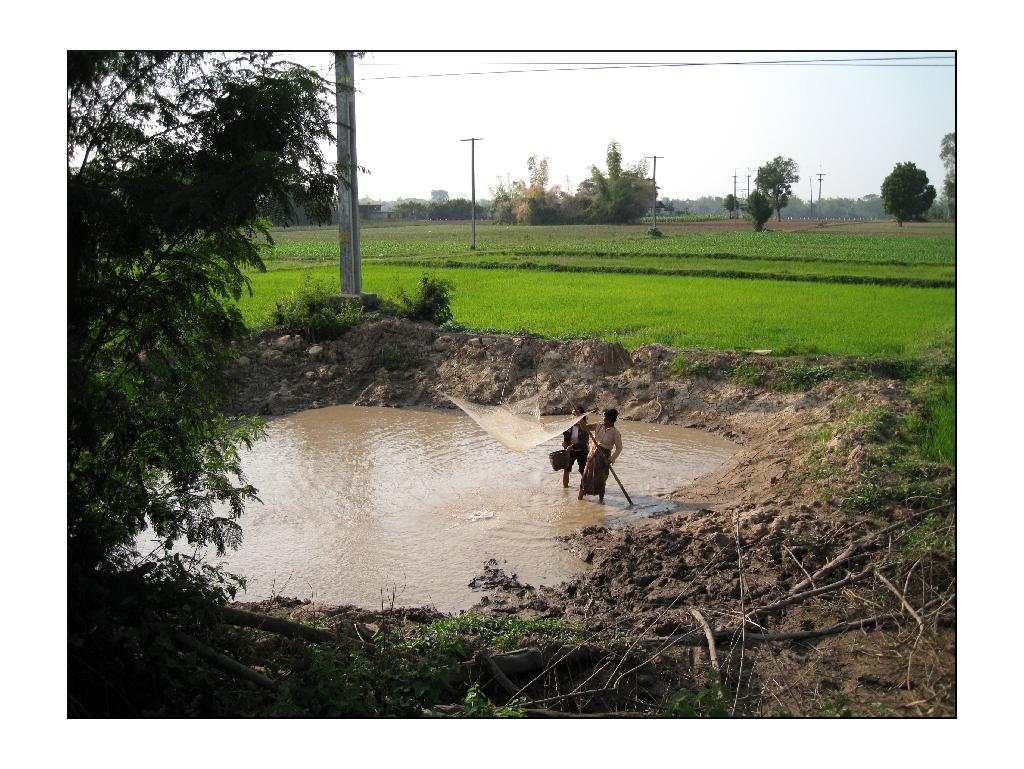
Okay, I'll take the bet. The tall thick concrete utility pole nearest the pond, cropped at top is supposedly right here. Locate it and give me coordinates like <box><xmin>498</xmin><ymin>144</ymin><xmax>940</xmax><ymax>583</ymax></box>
<box><xmin>334</xmin><ymin>51</ymin><xmax>362</xmax><ymax>296</ymax></box>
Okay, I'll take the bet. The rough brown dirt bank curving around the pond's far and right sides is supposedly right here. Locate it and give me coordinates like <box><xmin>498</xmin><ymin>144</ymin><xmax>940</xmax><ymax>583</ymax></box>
<box><xmin>231</xmin><ymin>319</ymin><xmax>955</xmax><ymax>715</ymax></box>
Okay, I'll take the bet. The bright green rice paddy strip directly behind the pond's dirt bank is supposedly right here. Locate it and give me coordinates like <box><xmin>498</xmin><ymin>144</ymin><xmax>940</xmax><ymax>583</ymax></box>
<box><xmin>235</xmin><ymin>263</ymin><xmax>954</xmax><ymax>358</ymax></box>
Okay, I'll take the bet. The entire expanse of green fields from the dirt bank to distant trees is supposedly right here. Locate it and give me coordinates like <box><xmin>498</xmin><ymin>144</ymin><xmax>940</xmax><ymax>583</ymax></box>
<box><xmin>240</xmin><ymin>222</ymin><xmax>955</xmax><ymax>358</ymax></box>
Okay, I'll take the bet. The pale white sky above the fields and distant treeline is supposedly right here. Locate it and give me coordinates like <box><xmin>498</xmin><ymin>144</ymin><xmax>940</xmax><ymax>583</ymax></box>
<box><xmin>295</xmin><ymin>50</ymin><xmax>956</xmax><ymax>200</ymax></box>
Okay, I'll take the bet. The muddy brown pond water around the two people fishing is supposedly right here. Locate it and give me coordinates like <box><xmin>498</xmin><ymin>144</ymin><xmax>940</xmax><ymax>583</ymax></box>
<box><xmin>211</xmin><ymin>405</ymin><xmax>735</xmax><ymax>611</ymax></box>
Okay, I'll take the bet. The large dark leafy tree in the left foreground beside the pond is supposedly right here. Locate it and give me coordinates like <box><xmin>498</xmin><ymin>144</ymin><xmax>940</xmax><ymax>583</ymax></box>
<box><xmin>68</xmin><ymin>51</ymin><xmax>336</xmax><ymax>714</ymax></box>
